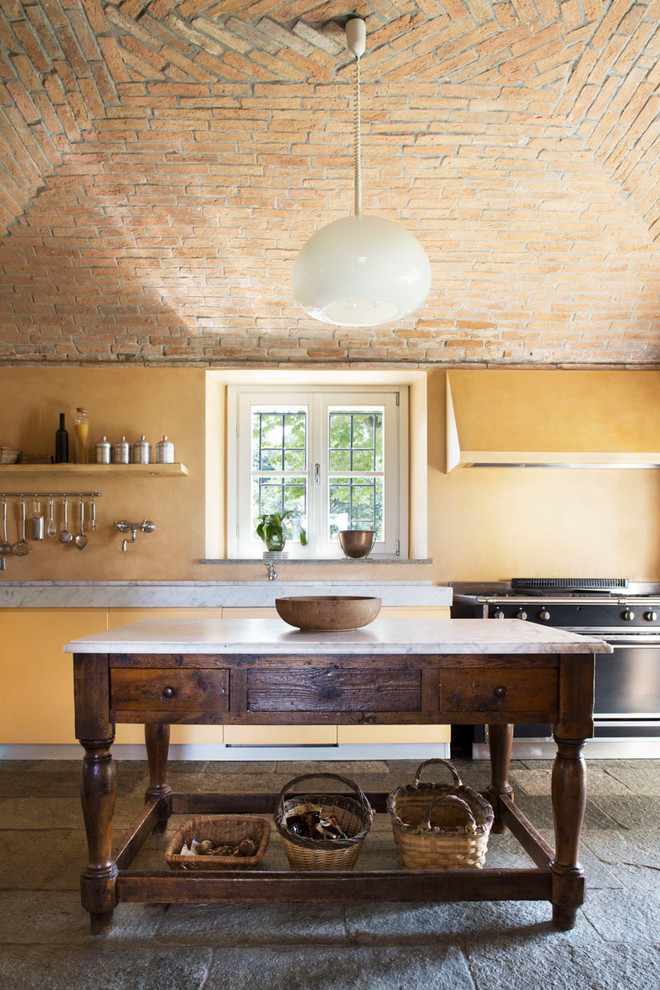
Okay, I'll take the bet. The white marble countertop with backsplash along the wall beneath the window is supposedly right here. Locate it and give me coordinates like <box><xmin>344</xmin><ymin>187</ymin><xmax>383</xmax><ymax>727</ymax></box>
<box><xmin>0</xmin><ymin>571</ymin><xmax>452</xmax><ymax>608</ymax></box>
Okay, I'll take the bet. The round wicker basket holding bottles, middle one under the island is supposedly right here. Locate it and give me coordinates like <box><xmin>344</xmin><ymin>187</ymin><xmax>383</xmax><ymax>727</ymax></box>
<box><xmin>275</xmin><ymin>773</ymin><xmax>374</xmax><ymax>870</ymax></box>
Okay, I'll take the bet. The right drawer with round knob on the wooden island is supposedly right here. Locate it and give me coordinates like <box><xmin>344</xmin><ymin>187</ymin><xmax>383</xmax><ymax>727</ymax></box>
<box><xmin>439</xmin><ymin>668</ymin><xmax>559</xmax><ymax>714</ymax></box>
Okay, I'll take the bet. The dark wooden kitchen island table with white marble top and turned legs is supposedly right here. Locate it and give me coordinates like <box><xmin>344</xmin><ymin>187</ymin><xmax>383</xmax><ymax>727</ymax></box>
<box><xmin>64</xmin><ymin>619</ymin><xmax>611</xmax><ymax>934</ymax></box>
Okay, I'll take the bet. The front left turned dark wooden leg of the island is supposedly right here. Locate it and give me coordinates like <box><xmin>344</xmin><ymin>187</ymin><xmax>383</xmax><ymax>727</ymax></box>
<box><xmin>80</xmin><ymin>738</ymin><xmax>117</xmax><ymax>935</ymax></box>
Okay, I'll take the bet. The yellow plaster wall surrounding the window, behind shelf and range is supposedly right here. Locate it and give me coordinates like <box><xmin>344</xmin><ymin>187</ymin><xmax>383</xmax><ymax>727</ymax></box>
<box><xmin>0</xmin><ymin>367</ymin><xmax>660</xmax><ymax>583</ymax></box>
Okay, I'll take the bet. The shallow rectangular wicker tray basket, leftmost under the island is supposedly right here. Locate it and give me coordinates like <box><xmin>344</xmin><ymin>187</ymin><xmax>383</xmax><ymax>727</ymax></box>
<box><xmin>165</xmin><ymin>815</ymin><xmax>270</xmax><ymax>870</ymax></box>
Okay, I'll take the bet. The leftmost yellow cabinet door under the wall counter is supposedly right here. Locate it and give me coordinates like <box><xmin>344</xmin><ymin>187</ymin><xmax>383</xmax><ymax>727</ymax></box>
<box><xmin>0</xmin><ymin>608</ymin><xmax>107</xmax><ymax>745</ymax></box>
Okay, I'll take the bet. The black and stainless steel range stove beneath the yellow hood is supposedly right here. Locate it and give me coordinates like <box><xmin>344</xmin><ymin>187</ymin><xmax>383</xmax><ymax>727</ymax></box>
<box><xmin>451</xmin><ymin>578</ymin><xmax>660</xmax><ymax>758</ymax></box>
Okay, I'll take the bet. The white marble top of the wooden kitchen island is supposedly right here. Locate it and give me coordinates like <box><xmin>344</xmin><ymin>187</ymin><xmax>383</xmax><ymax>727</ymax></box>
<box><xmin>64</xmin><ymin>617</ymin><xmax>612</xmax><ymax>655</ymax></box>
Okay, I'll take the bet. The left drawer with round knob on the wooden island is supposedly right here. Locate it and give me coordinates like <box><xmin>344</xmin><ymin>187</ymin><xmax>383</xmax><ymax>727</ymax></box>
<box><xmin>110</xmin><ymin>667</ymin><xmax>229</xmax><ymax>714</ymax></box>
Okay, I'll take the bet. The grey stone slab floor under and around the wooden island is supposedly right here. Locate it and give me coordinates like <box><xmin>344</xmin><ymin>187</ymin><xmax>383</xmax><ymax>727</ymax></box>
<box><xmin>0</xmin><ymin>760</ymin><xmax>660</xmax><ymax>990</ymax></box>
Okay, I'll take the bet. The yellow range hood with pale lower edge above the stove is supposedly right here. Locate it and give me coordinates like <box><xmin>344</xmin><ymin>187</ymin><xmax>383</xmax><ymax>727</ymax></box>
<box><xmin>445</xmin><ymin>369</ymin><xmax>660</xmax><ymax>473</ymax></box>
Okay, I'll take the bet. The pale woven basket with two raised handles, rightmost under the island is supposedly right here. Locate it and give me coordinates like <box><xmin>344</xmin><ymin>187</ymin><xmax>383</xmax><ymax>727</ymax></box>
<box><xmin>387</xmin><ymin>759</ymin><xmax>493</xmax><ymax>870</ymax></box>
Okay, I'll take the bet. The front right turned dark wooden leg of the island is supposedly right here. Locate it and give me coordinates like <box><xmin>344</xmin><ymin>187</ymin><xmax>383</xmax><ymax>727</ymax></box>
<box><xmin>550</xmin><ymin>736</ymin><xmax>587</xmax><ymax>930</ymax></box>
